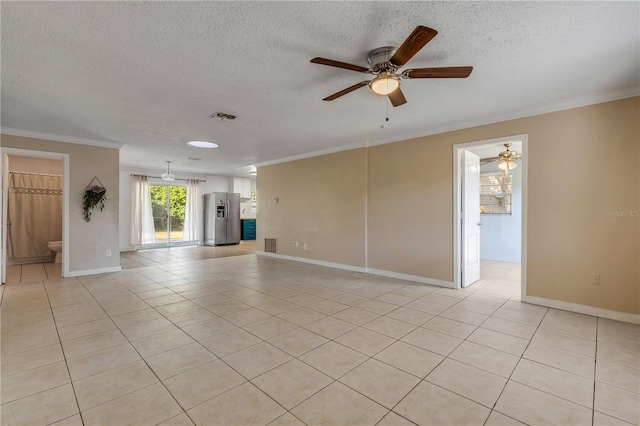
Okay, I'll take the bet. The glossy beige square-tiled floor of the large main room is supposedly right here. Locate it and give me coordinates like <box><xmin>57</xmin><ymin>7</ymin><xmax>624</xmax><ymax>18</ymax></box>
<box><xmin>0</xmin><ymin>255</ymin><xmax>640</xmax><ymax>425</ymax></box>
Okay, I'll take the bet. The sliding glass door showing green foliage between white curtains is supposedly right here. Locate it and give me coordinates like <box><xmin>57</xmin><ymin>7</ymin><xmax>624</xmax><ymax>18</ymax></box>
<box><xmin>149</xmin><ymin>185</ymin><xmax>190</xmax><ymax>247</ymax></box>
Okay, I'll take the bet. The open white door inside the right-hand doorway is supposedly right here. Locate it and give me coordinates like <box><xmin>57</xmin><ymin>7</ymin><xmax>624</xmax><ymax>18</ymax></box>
<box><xmin>462</xmin><ymin>150</ymin><xmax>480</xmax><ymax>287</ymax></box>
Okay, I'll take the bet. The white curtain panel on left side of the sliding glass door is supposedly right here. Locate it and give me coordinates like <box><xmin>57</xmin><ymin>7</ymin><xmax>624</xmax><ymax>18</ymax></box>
<box><xmin>130</xmin><ymin>175</ymin><xmax>156</xmax><ymax>247</ymax></box>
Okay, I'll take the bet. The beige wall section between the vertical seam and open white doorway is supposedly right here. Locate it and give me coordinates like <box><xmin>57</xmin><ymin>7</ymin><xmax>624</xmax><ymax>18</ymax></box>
<box><xmin>368</xmin><ymin>135</ymin><xmax>453</xmax><ymax>281</ymax></box>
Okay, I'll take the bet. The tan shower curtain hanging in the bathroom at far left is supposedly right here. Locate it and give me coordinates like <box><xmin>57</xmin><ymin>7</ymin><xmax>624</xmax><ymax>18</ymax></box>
<box><xmin>7</xmin><ymin>172</ymin><xmax>62</xmax><ymax>262</ymax></box>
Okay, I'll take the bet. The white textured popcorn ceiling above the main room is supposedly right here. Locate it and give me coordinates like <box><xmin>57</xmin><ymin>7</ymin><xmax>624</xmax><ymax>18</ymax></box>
<box><xmin>0</xmin><ymin>1</ymin><xmax>640</xmax><ymax>175</ymax></box>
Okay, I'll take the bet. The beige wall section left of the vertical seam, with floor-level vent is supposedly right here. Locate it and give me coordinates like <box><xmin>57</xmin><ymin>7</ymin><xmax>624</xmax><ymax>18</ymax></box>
<box><xmin>257</xmin><ymin>149</ymin><xmax>366</xmax><ymax>267</ymax></box>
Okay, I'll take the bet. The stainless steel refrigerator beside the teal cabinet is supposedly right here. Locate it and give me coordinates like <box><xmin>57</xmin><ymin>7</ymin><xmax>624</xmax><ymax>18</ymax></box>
<box><xmin>204</xmin><ymin>192</ymin><xmax>240</xmax><ymax>246</ymax></box>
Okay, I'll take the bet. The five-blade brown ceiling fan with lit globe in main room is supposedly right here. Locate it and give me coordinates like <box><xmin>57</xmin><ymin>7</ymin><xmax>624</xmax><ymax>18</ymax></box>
<box><xmin>311</xmin><ymin>26</ymin><xmax>473</xmax><ymax>107</ymax></box>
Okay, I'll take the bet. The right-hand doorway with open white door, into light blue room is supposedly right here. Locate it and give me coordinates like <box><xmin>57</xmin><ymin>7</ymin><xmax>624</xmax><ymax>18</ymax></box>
<box><xmin>453</xmin><ymin>135</ymin><xmax>527</xmax><ymax>298</ymax></box>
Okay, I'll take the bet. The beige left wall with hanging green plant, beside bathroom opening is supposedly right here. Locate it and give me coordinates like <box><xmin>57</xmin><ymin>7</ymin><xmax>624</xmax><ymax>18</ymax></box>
<box><xmin>0</xmin><ymin>135</ymin><xmax>120</xmax><ymax>273</ymax></box>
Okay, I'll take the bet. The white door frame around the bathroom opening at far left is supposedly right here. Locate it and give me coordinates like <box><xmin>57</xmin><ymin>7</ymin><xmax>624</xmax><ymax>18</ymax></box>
<box><xmin>0</xmin><ymin>148</ymin><xmax>69</xmax><ymax>283</ymax></box>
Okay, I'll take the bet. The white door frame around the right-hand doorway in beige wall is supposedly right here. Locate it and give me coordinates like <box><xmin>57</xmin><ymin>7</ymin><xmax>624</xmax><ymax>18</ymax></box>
<box><xmin>453</xmin><ymin>134</ymin><xmax>529</xmax><ymax>299</ymax></box>
